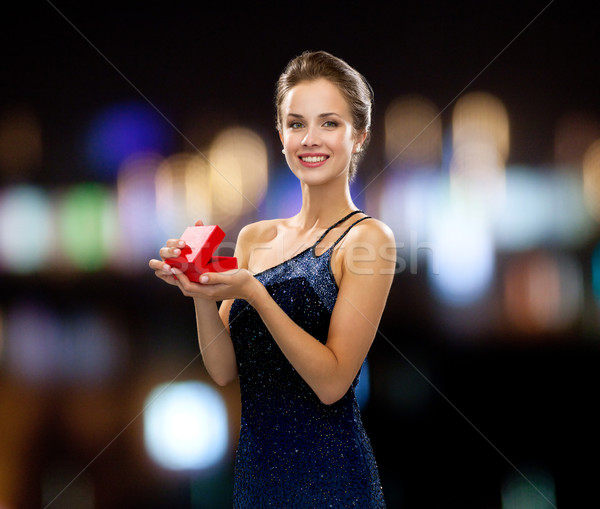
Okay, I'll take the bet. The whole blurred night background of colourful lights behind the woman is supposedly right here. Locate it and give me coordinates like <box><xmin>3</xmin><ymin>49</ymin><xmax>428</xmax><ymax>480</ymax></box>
<box><xmin>0</xmin><ymin>0</ymin><xmax>600</xmax><ymax>509</ymax></box>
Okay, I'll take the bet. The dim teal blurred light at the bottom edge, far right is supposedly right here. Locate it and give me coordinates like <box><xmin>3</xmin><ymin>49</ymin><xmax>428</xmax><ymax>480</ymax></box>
<box><xmin>501</xmin><ymin>467</ymin><xmax>556</xmax><ymax>509</ymax></box>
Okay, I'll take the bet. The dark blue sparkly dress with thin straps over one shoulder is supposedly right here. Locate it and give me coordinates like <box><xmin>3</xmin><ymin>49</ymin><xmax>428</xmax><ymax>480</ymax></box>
<box><xmin>229</xmin><ymin>211</ymin><xmax>385</xmax><ymax>509</ymax></box>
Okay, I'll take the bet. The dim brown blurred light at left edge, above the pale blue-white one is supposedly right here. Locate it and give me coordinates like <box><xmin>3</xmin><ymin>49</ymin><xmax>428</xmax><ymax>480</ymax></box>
<box><xmin>0</xmin><ymin>107</ymin><xmax>42</xmax><ymax>179</ymax></box>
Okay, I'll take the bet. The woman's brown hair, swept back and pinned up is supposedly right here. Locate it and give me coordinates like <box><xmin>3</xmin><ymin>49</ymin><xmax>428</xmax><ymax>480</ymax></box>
<box><xmin>275</xmin><ymin>51</ymin><xmax>373</xmax><ymax>179</ymax></box>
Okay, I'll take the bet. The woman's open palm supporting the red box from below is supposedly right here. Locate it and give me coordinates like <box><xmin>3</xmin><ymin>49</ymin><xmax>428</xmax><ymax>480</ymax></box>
<box><xmin>169</xmin><ymin>269</ymin><xmax>264</xmax><ymax>303</ymax></box>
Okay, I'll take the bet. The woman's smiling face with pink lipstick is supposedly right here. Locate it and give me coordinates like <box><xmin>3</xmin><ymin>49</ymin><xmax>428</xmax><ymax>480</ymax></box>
<box><xmin>279</xmin><ymin>79</ymin><xmax>364</xmax><ymax>185</ymax></box>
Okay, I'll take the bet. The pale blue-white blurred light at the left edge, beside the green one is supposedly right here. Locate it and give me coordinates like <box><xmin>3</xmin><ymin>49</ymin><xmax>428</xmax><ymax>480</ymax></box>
<box><xmin>0</xmin><ymin>185</ymin><xmax>53</xmax><ymax>273</ymax></box>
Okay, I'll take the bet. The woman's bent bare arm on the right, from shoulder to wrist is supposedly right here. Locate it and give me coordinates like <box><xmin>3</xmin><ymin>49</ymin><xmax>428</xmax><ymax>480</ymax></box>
<box><xmin>247</xmin><ymin>220</ymin><xmax>396</xmax><ymax>404</ymax></box>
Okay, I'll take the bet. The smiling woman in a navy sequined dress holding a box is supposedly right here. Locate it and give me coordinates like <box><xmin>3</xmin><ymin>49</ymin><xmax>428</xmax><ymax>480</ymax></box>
<box><xmin>150</xmin><ymin>52</ymin><xmax>395</xmax><ymax>509</ymax></box>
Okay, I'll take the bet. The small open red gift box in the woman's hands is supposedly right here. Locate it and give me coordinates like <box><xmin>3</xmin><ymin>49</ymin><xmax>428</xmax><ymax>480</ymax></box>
<box><xmin>166</xmin><ymin>225</ymin><xmax>238</xmax><ymax>283</ymax></box>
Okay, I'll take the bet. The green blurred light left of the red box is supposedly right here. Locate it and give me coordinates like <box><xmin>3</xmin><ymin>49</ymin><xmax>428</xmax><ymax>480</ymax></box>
<box><xmin>58</xmin><ymin>183</ymin><xmax>119</xmax><ymax>271</ymax></box>
